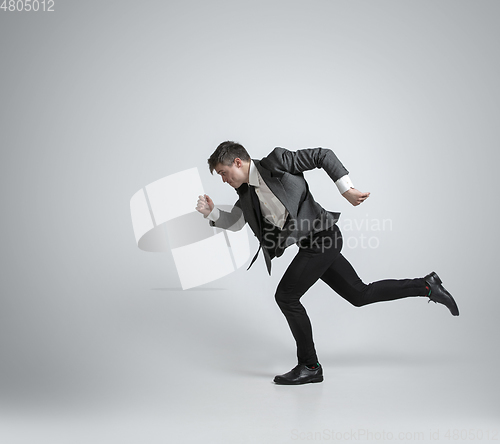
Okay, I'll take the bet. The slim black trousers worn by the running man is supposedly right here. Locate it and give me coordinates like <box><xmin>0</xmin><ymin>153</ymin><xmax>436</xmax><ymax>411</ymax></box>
<box><xmin>275</xmin><ymin>225</ymin><xmax>427</xmax><ymax>364</ymax></box>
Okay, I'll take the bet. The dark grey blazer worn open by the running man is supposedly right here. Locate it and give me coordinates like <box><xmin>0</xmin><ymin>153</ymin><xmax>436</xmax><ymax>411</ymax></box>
<box><xmin>210</xmin><ymin>148</ymin><xmax>349</xmax><ymax>273</ymax></box>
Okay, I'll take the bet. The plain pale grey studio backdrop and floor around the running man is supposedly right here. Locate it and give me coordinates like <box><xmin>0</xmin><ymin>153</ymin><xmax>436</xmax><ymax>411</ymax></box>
<box><xmin>0</xmin><ymin>0</ymin><xmax>500</xmax><ymax>443</ymax></box>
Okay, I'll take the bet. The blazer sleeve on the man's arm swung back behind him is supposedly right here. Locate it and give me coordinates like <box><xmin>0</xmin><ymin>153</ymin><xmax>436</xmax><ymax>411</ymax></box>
<box><xmin>261</xmin><ymin>147</ymin><xmax>349</xmax><ymax>182</ymax></box>
